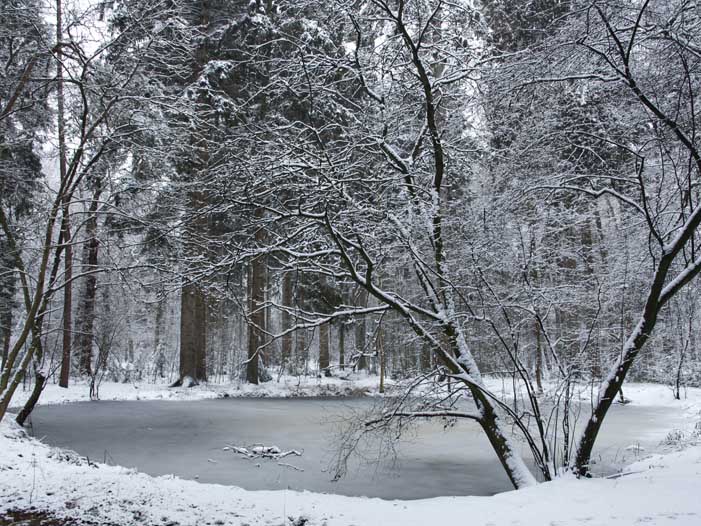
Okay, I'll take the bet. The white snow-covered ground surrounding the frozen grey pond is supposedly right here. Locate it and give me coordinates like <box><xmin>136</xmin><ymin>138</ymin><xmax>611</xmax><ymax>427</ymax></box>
<box><xmin>0</xmin><ymin>377</ymin><xmax>701</xmax><ymax>526</ymax></box>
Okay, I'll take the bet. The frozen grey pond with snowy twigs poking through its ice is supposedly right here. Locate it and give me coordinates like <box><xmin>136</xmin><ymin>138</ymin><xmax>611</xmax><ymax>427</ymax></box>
<box><xmin>26</xmin><ymin>398</ymin><xmax>678</xmax><ymax>499</ymax></box>
